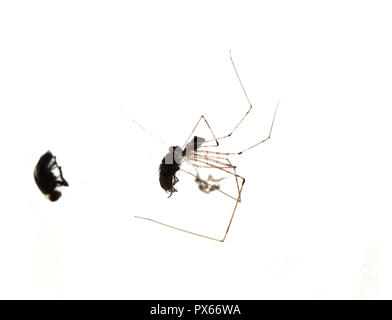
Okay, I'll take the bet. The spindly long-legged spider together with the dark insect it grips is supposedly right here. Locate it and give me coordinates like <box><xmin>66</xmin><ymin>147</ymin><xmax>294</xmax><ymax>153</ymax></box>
<box><xmin>131</xmin><ymin>51</ymin><xmax>279</xmax><ymax>242</ymax></box>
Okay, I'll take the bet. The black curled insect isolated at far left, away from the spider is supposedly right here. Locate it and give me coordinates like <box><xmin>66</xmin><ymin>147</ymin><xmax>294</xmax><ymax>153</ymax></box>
<box><xmin>34</xmin><ymin>151</ymin><xmax>68</xmax><ymax>201</ymax></box>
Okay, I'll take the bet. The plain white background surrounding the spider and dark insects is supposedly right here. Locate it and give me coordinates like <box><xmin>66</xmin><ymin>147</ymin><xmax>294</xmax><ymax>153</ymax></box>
<box><xmin>0</xmin><ymin>0</ymin><xmax>392</xmax><ymax>299</ymax></box>
